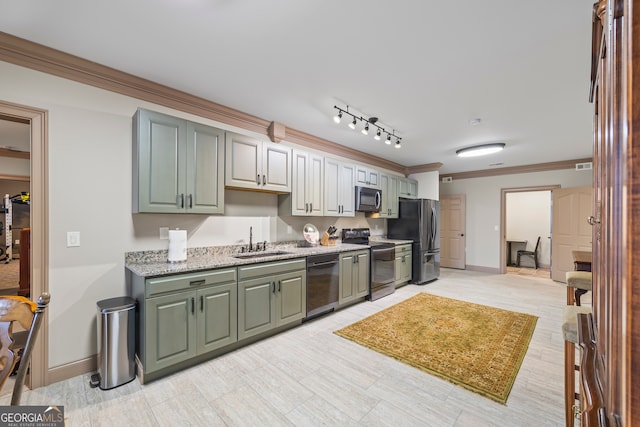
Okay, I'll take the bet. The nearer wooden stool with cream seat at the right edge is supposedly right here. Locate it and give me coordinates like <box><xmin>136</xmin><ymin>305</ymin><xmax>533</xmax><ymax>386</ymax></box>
<box><xmin>562</xmin><ymin>306</ymin><xmax>591</xmax><ymax>427</ymax></box>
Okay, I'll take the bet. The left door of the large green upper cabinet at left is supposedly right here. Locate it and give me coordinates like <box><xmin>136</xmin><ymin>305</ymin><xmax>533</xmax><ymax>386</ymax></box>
<box><xmin>132</xmin><ymin>110</ymin><xmax>187</xmax><ymax>213</ymax></box>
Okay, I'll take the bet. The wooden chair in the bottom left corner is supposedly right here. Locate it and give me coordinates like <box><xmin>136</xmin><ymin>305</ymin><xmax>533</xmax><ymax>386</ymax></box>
<box><xmin>0</xmin><ymin>293</ymin><xmax>50</xmax><ymax>406</ymax></box>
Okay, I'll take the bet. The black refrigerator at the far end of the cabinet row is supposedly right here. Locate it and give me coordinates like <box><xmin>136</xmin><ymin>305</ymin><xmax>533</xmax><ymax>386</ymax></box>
<box><xmin>387</xmin><ymin>199</ymin><xmax>440</xmax><ymax>284</ymax></box>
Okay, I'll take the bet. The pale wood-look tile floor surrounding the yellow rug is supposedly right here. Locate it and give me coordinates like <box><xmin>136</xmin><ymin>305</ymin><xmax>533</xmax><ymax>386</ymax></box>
<box><xmin>0</xmin><ymin>269</ymin><xmax>566</xmax><ymax>427</ymax></box>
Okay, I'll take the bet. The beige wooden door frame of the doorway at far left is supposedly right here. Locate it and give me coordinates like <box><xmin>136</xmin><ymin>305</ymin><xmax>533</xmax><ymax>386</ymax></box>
<box><xmin>0</xmin><ymin>101</ymin><xmax>51</xmax><ymax>389</ymax></box>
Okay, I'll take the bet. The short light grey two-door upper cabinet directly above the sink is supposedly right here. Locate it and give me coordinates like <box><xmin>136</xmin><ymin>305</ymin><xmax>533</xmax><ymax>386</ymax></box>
<box><xmin>225</xmin><ymin>132</ymin><xmax>291</xmax><ymax>193</ymax></box>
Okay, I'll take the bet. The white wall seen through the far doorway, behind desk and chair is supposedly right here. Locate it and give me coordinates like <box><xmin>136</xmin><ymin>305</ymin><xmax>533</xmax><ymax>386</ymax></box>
<box><xmin>505</xmin><ymin>190</ymin><xmax>551</xmax><ymax>266</ymax></box>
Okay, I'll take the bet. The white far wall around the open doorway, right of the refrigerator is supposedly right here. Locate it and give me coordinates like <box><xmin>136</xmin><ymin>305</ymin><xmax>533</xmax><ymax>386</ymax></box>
<box><xmin>440</xmin><ymin>169</ymin><xmax>592</xmax><ymax>270</ymax></box>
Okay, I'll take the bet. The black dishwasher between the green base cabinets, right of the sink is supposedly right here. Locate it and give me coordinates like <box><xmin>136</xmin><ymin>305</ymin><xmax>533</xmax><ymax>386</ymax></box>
<box><xmin>304</xmin><ymin>253</ymin><xmax>340</xmax><ymax>320</ymax></box>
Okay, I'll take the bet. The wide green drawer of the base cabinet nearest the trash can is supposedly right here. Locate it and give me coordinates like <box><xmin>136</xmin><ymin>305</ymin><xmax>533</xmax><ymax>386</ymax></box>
<box><xmin>145</xmin><ymin>268</ymin><xmax>237</xmax><ymax>298</ymax></box>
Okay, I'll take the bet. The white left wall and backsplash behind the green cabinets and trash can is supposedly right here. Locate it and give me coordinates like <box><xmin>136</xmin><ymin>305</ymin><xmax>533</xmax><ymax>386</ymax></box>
<box><xmin>0</xmin><ymin>62</ymin><xmax>410</xmax><ymax>368</ymax></box>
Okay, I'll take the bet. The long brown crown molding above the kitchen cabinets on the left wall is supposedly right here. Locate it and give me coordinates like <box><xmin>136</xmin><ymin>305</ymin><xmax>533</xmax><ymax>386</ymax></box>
<box><xmin>0</xmin><ymin>32</ymin><xmax>405</xmax><ymax>173</ymax></box>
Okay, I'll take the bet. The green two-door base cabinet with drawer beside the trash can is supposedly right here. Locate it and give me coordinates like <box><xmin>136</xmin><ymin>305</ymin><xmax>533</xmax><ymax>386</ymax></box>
<box><xmin>133</xmin><ymin>268</ymin><xmax>237</xmax><ymax>374</ymax></box>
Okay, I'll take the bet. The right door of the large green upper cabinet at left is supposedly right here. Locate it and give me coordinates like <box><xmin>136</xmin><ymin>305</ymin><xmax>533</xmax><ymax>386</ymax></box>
<box><xmin>185</xmin><ymin>123</ymin><xmax>224</xmax><ymax>214</ymax></box>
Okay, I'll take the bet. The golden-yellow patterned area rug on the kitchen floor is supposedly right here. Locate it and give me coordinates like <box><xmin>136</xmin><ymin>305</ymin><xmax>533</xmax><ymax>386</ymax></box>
<box><xmin>335</xmin><ymin>293</ymin><xmax>538</xmax><ymax>404</ymax></box>
